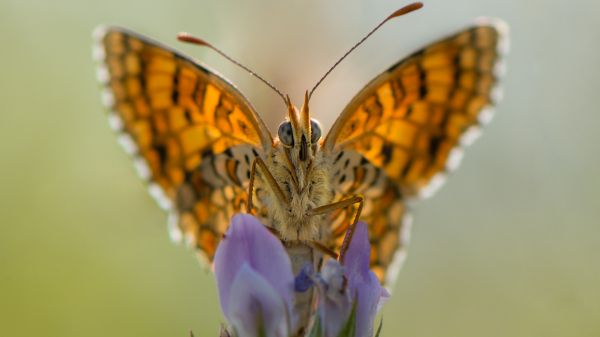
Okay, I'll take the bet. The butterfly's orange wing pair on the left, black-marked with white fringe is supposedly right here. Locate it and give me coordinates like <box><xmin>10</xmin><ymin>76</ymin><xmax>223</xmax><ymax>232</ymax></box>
<box><xmin>94</xmin><ymin>27</ymin><xmax>272</xmax><ymax>261</ymax></box>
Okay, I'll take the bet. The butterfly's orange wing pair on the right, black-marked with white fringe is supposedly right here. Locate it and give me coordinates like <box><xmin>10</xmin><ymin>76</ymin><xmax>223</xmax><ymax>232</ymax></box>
<box><xmin>323</xmin><ymin>21</ymin><xmax>506</xmax><ymax>281</ymax></box>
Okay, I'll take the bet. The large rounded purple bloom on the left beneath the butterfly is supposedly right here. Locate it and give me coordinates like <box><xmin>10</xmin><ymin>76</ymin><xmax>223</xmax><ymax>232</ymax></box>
<box><xmin>215</xmin><ymin>214</ymin><xmax>294</xmax><ymax>337</ymax></box>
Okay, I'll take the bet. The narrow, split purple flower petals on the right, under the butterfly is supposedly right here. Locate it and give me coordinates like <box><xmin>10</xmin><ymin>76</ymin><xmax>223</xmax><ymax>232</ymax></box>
<box><xmin>319</xmin><ymin>222</ymin><xmax>390</xmax><ymax>337</ymax></box>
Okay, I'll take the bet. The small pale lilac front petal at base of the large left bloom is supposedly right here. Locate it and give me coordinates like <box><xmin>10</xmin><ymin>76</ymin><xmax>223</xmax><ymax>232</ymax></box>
<box><xmin>228</xmin><ymin>263</ymin><xmax>290</xmax><ymax>337</ymax></box>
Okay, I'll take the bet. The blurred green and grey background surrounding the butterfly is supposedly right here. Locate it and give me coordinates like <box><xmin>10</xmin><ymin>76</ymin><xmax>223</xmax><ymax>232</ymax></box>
<box><xmin>0</xmin><ymin>0</ymin><xmax>600</xmax><ymax>337</ymax></box>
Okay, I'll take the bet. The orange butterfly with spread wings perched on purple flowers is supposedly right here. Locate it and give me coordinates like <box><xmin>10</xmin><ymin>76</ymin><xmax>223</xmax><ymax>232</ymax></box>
<box><xmin>94</xmin><ymin>2</ymin><xmax>507</xmax><ymax>292</ymax></box>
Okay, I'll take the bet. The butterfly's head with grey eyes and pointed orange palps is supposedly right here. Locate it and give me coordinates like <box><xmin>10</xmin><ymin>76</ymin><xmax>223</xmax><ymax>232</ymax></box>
<box><xmin>277</xmin><ymin>92</ymin><xmax>321</xmax><ymax>162</ymax></box>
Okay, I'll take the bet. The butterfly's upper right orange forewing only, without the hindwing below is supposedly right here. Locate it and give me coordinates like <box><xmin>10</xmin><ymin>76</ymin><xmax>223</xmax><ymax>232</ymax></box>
<box><xmin>324</xmin><ymin>24</ymin><xmax>503</xmax><ymax>196</ymax></box>
